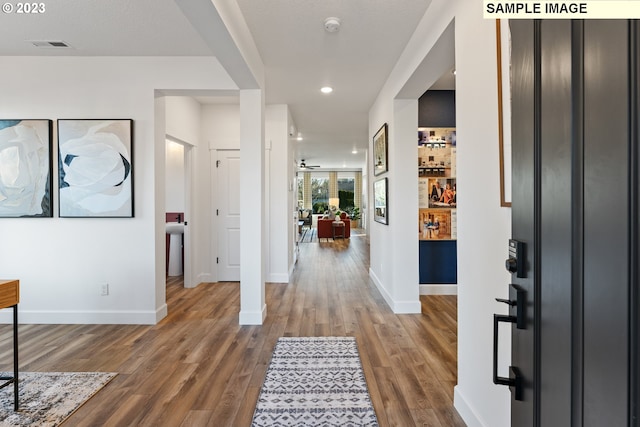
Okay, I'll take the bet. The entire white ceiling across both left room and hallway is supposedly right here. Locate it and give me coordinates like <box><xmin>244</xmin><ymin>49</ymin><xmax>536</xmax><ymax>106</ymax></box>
<box><xmin>0</xmin><ymin>0</ymin><xmax>451</xmax><ymax>168</ymax></box>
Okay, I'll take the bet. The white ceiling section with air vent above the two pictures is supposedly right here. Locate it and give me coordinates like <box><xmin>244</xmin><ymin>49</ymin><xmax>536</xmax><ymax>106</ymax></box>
<box><xmin>0</xmin><ymin>0</ymin><xmax>211</xmax><ymax>56</ymax></box>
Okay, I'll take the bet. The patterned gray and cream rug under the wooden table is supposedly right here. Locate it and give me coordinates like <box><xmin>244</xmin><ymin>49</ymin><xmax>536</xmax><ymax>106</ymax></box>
<box><xmin>0</xmin><ymin>372</ymin><xmax>117</xmax><ymax>427</ymax></box>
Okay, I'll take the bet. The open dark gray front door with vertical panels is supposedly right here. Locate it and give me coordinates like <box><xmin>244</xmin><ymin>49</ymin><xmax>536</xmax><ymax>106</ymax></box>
<box><xmin>505</xmin><ymin>20</ymin><xmax>640</xmax><ymax>427</ymax></box>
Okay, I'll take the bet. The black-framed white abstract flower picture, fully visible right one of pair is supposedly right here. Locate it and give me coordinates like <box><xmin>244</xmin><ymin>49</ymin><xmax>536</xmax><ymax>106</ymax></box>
<box><xmin>58</xmin><ymin>119</ymin><xmax>133</xmax><ymax>218</ymax></box>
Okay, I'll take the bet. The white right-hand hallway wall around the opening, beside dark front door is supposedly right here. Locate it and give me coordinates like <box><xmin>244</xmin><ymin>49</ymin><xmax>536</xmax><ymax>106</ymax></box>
<box><xmin>368</xmin><ymin>0</ymin><xmax>511</xmax><ymax>427</ymax></box>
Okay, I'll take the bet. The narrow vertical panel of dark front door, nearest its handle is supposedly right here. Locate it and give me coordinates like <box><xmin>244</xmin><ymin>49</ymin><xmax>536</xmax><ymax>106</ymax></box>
<box><xmin>539</xmin><ymin>20</ymin><xmax>572</xmax><ymax>426</ymax></box>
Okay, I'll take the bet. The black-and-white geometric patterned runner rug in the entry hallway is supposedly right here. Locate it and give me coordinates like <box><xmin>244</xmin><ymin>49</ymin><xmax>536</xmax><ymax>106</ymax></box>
<box><xmin>252</xmin><ymin>337</ymin><xmax>378</xmax><ymax>427</ymax></box>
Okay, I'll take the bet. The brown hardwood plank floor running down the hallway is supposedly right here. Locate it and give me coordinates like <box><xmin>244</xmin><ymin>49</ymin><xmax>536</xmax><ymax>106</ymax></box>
<box><xmin>0</xmin><ymin>237</ymin><xmax>464</xmax><ymax>427</ymax></box>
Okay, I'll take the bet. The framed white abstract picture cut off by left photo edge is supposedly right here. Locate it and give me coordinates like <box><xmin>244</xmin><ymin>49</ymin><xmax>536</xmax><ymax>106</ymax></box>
<box><xmin>0</xmin><ymin>120</ymin><xmax>53</xmax><ymax>218</ymax></box>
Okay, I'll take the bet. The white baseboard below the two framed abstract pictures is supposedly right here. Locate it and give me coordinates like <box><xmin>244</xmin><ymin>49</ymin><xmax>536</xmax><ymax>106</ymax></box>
<box><xmin>0</xmin><ymin>304</ymin><xmax>167</xmax><ymax>325</ymax></box>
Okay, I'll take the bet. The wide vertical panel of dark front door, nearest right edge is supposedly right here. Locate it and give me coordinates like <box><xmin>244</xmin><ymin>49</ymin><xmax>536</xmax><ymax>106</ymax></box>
<box><xmin>584</xmin><ymin>20</ymin><xmax>629</xmax><ymax>426</ymax></box>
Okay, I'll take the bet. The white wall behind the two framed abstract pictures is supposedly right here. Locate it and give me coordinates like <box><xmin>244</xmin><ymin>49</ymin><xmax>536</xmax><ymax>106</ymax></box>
<box><xmin>0</xmin><ymin>57</ymin><xmax>236</xmax><ymax>324</ymax></box>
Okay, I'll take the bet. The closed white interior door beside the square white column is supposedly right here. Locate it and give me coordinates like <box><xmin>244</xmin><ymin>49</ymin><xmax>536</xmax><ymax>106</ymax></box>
<box><xmin>216</xmin><ymin>150</ymin><xmax>240</xmax><ymax>282</ymax></box>
